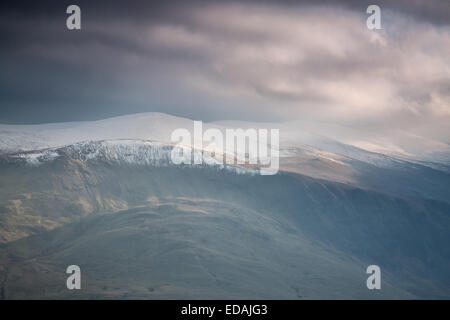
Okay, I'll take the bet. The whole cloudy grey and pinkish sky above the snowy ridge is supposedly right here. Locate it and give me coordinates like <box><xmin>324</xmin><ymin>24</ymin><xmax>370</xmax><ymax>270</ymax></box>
<box><xmin>0</xmin><ymin>0</ymin><xmax>450</xmax><ymax>143</ymax></box>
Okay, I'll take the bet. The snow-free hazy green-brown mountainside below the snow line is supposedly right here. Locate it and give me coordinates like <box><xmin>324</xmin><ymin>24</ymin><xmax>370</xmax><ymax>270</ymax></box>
<box><xmin>0</xmin><ymin>158</ymin><xmax>450</xmax><ymax>299</ymax></box>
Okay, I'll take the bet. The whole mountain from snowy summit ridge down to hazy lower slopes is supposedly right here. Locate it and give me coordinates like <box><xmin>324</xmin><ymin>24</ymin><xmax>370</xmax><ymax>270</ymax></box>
<box><xmin>0</xmin><ymin>113</ymin><xmax>450</xmax><ymax>299</ymax></box>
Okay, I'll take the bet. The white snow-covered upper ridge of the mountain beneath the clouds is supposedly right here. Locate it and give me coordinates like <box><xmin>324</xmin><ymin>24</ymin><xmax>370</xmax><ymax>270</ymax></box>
<box><xmin>0</xmin><ymin>112</ymin><xmax>450</xmax><ymax>172</ymax></box>
